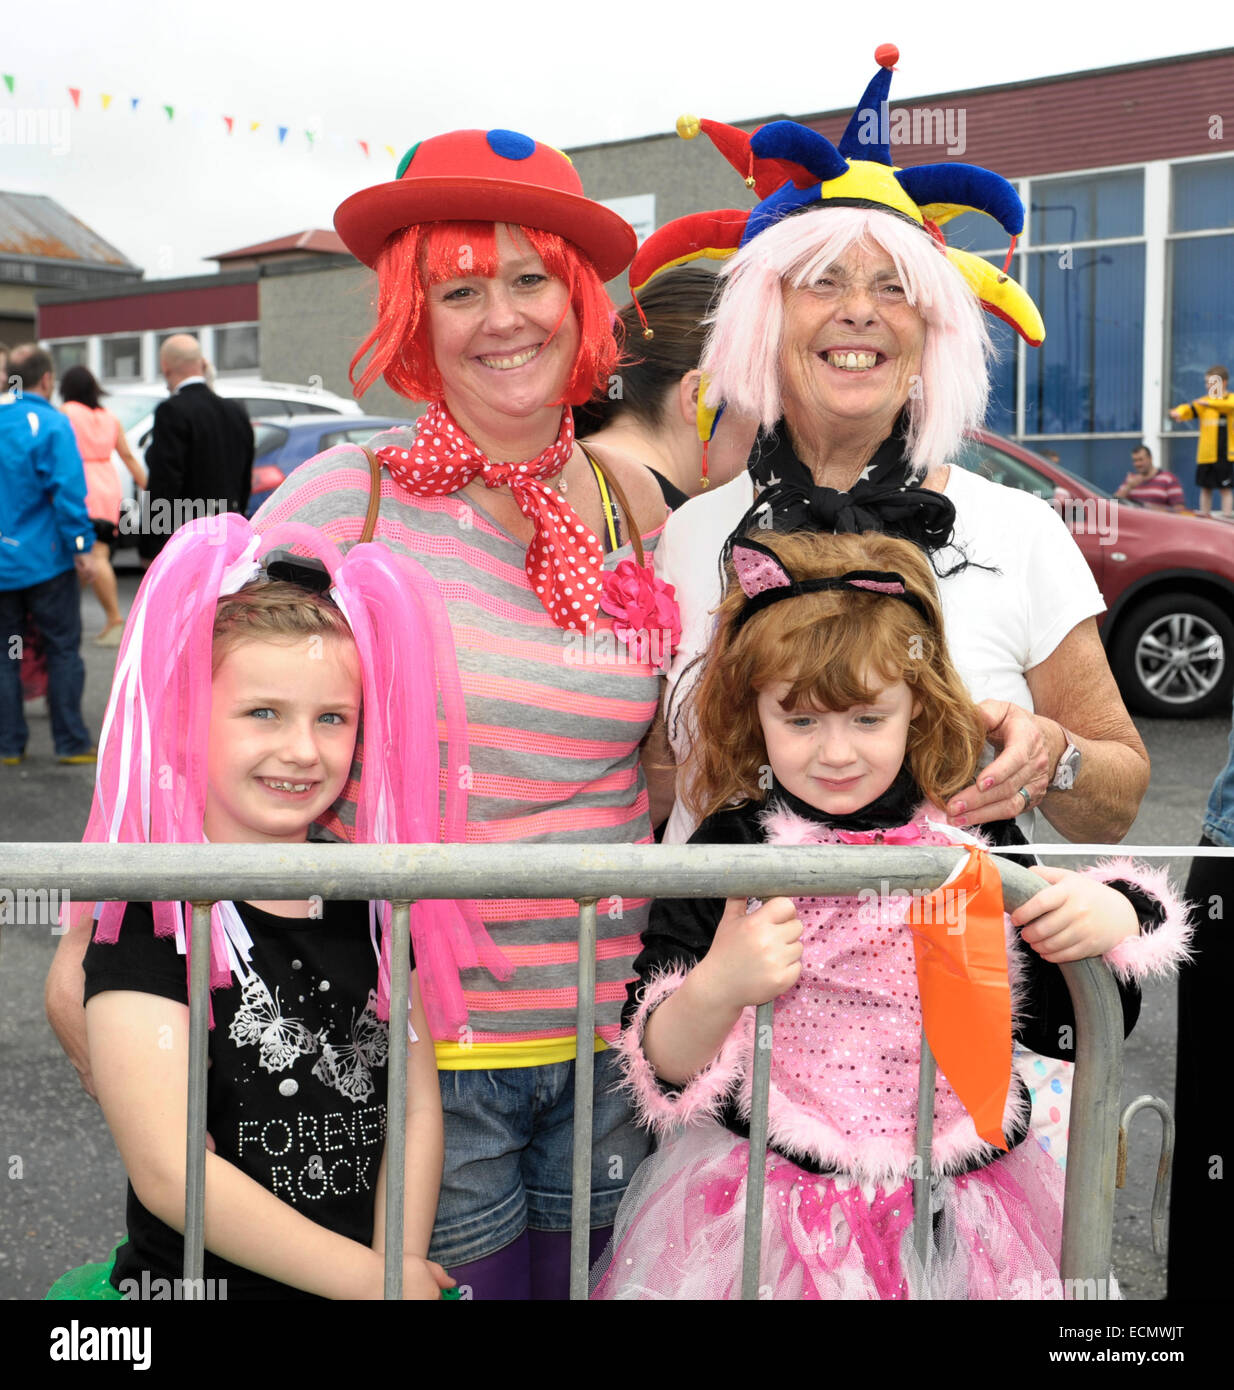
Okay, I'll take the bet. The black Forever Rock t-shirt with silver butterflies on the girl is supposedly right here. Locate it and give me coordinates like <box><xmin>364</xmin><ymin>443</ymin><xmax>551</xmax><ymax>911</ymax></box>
<box><xmin>85</xmin><ymin>902</ymin><xmax>408</xmax><ymax>1298</ymax></box>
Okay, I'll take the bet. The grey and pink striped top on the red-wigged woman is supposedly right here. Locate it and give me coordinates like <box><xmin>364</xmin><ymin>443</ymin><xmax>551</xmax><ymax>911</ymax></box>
<box><xmin>256</xmin><ymin>444</ymin><xmax>660</xmax><ymax>1068</ymax></box>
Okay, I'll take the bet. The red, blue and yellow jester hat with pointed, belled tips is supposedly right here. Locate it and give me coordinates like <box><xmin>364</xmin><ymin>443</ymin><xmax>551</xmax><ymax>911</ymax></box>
<box><xmin>630</xmin><ymin>43</ymin><xmax>1045</xmax><ymax>455</ymax></box>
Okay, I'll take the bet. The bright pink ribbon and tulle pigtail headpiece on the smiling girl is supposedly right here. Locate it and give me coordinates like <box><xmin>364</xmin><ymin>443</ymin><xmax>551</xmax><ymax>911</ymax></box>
<box><xmin>82</xmin><ymin>513</ymin><xmax>511</xmax><ymax>1037</ymax></box>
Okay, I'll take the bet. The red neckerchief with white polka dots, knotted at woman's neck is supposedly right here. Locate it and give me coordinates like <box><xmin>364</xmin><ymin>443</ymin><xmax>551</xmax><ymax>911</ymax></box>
<box><xmin>377</xmin><ymin>400</ymin><xmax>604</xmax><ymax>632</ymax></box>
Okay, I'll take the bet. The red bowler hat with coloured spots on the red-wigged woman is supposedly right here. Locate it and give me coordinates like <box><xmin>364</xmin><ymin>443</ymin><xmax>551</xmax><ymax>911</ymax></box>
<box><xmin>335</xmin><ymin>131</ymin><xmax>638</xmax><ymax>281</ymax></box>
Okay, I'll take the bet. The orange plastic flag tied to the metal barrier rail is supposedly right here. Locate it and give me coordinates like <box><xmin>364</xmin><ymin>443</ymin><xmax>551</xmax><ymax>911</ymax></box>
<box><xmin>905</xmin><ymin>847</ymin><xmax>1012</xmax><ymax>1150</ymax></box>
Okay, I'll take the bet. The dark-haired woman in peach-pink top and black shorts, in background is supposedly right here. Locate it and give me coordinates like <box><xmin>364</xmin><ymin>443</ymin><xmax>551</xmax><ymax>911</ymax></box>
<box><xmin>60</xmin><ymin>367</ymin><xmax>146</xmax><ymax>646</ymax></box>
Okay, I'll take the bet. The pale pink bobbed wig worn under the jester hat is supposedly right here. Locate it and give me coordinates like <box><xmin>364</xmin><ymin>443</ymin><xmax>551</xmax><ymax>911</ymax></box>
<box><xmin>702</xmin><ymin>207</ymin><xmax>992</xmax><ymax>473</ymax></box>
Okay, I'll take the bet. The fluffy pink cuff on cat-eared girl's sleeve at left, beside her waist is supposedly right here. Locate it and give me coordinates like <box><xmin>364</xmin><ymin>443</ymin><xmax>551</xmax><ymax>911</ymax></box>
<box><xmin>616</xmin><ymin>970</ymin><xmax>755</xmax><ymax>1134</ymax></box>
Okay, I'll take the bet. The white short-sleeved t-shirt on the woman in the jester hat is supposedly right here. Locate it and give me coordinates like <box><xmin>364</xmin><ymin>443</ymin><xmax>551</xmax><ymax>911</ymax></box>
<box><xmin>656</xmin><ymin>466</ymin><xmax>1105</xmax><ymax>844</ymax></box>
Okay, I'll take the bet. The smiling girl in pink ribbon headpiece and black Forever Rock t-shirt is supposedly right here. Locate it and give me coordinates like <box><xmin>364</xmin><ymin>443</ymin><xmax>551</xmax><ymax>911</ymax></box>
<box><xmin>61</xmin><ymin>514</ymin><xmax>504</xmax><ymax>1298</ymax></box>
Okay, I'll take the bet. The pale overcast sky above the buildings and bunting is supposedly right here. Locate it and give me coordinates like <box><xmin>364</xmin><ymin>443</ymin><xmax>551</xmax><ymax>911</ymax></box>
<box><xmin>0</xmin><ymin>0</ymin><xmax>1234</xmax><ymax>278</ymax></box>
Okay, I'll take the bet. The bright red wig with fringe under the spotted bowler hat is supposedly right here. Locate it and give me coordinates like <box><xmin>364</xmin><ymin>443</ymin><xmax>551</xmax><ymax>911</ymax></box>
<box><xmin>349</xmin><ymin>222</ymin><xmax>617</xmax><ymax>406</ymax></box>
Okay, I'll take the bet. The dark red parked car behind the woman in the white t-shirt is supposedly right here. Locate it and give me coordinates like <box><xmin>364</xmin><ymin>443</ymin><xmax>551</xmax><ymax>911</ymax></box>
<box><xmin>960</xmin><ymin>430</ymin><xmax>1234</xmax><ymax>719</ymax></box>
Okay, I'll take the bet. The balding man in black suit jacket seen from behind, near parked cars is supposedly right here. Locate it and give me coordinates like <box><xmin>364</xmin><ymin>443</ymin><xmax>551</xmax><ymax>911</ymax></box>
<box><xmin>138</xmin><ymin>334</ymin><xmax>253</xmax><ymax>560</ymax></box>
